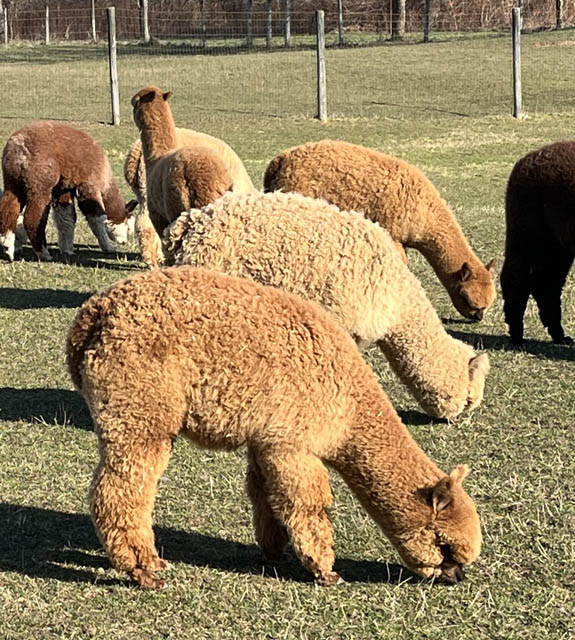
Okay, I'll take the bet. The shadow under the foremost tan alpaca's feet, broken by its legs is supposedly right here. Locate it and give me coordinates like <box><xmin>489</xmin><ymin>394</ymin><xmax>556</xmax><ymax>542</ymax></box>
<box><xmin>0</xmin><ymin>503</ymin><xmax>419</xmax><ymax>586</ymax></box>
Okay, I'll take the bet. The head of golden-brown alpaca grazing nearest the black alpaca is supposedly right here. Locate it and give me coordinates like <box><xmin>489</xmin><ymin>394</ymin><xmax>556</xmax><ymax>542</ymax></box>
<box><xmin>449</xmin><ymin>259</ymin><xmax>495</xmax><ymax>321</ymax></box>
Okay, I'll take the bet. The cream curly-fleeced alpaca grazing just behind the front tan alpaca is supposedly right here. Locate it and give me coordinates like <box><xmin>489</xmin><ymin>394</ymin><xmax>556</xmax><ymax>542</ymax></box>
<box><xmin>165</xmin><ymin>191</ymin><xmax>489</xmax><ymax>418</ymax></box>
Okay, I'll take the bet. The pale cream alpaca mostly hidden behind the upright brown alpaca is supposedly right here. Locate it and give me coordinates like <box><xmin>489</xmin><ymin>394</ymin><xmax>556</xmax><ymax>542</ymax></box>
<box><xmin>124</xmin><ymin>127</ymin><xmax>254</xmax><ymax>266</ymax></box>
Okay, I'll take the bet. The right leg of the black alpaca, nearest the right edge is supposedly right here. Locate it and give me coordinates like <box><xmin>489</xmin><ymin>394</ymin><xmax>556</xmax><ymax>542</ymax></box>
<box><xmin>533</xmin><ymin>244</ymin><xmax>574</xmax><ymax>344</ymax></box>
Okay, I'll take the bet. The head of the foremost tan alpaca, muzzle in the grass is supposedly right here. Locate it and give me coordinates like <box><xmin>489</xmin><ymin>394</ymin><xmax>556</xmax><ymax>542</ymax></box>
<box><xmin>395</xmin><ymin>465</ymin><xmax>481</xmax><ymax>584</ymax></box>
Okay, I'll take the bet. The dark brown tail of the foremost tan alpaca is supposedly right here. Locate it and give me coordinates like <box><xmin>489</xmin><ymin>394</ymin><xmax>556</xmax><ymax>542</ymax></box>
<box><xmin>66</xmin><ymin>294</ymin><xmax>110</xmax><ymax>391</ymax></box>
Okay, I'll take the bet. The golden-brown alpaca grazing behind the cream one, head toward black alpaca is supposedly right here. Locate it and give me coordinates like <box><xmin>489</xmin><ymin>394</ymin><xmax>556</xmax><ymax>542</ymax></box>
<box><xmin>264</xmin><ymin>140</ymin><xmax>495</xmax><ymax>321</ymax></box>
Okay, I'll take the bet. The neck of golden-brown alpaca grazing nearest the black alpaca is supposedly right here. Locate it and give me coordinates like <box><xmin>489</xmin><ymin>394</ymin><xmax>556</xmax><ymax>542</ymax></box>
<box><xmin>414</xmin><ymin>199</ymin><xmax>482</xmax><ymax>291</ymax></box>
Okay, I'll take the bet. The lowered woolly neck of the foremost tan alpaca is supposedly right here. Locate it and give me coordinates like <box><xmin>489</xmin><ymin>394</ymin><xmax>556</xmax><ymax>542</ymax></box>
<box><xmin>331</xmin><ymin>380</ymin><xmax>445</xmax><ymax>543</ymax></box>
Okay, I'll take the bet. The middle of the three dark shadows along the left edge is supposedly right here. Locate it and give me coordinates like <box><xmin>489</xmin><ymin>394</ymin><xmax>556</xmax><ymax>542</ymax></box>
<box><xmin>0</xmin><ymin>387</ymin><xmax>93</xmax><ymax>431</ymax></box>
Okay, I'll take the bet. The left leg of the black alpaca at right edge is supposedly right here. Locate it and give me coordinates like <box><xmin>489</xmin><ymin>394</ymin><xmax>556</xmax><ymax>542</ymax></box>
<box><xmin>501</xmin><ymin>254</ymin><xmax>532</xmax><ymax>345</ymax></box>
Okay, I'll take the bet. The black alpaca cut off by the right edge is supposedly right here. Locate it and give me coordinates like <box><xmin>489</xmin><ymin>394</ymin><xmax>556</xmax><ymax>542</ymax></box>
<box><xmin>501</xmin><ymin>141</ymin><xmax>575</xmax><ymax>345</ymax></box>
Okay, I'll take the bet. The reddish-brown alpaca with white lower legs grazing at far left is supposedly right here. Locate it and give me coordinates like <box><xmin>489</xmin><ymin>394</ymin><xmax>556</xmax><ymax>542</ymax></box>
<box><xmin>0</xmin><ymin>121</ymin><xmax>137</xmax><ymax>260</ymax></box>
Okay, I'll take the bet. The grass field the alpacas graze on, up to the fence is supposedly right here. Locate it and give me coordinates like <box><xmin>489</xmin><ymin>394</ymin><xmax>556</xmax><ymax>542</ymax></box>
<box><xmin>0</xmin><ymin>32</ymin><xmax>575</xmax><ymax>640</ymax></box>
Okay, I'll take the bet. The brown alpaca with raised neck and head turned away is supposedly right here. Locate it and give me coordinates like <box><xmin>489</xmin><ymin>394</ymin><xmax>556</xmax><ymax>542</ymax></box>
<box><xmin>132</xmin><ymin>86</ymin><xmax>233</xmax><ymax>255</ymax></box>
